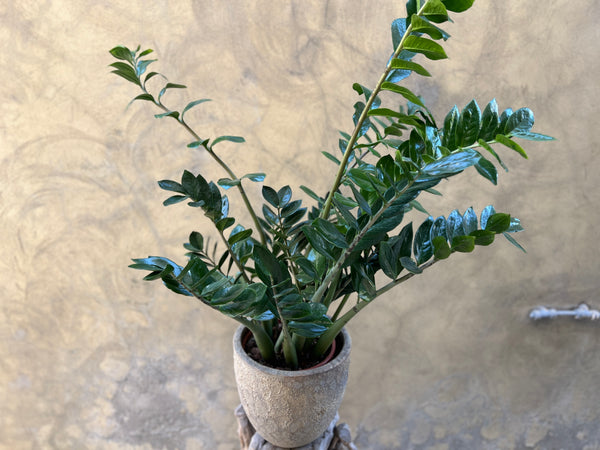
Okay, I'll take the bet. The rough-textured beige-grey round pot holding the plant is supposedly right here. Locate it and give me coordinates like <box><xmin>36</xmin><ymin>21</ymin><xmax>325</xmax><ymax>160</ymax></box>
<box><xmin>233</xmin><ymin>327</ymin><xmax>351</xmax><ymax>448</ymax></box>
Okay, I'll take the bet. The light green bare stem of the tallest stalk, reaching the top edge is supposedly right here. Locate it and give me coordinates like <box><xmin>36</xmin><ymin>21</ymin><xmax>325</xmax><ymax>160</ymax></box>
<box><xmin>320</xmin><ymin>2</ymin><xmax>427</xmax><ymax>219</ymax></box>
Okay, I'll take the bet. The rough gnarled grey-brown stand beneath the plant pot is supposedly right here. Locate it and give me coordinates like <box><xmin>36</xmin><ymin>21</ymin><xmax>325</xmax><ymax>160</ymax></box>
<box><xmin>235</xmin><ymin>405</ymin><xmax>356</xmax><ymax>450</ymax></box>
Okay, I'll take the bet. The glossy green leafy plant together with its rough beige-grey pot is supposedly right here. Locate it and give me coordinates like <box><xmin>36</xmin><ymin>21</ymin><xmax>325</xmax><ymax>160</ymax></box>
<box><xmin>110</xmin><ymin>0</ymin><xmax>552</xmax><ymax>447</ymax></box>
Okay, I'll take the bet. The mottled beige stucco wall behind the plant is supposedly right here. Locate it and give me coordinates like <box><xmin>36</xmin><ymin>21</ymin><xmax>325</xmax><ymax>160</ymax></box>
<box><xmin>0</xmin><ymin>0</ymin><xmax>600</xmax><ymax>449</ymax></box>
